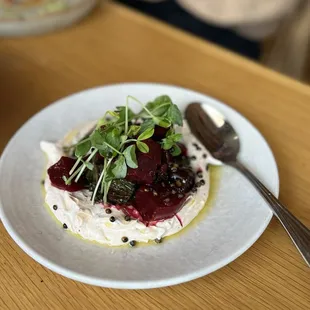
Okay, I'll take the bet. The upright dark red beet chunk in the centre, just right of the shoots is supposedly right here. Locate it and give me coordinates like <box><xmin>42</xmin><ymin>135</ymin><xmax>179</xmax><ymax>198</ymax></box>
<box><xmin>126</xmin><ymin>139</ymin><xmax>162</xmax><ymax>184</ymax></box>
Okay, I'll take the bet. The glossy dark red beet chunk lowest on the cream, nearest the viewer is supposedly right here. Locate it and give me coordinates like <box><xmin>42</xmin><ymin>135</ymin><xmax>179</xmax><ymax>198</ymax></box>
<box><xmin>133</xmin><ymin>184</ymin><xmax>187</xmax><ymax>224</ymax></box>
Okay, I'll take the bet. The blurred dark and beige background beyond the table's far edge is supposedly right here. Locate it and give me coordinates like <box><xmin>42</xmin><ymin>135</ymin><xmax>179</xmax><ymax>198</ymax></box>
<box><xmin>117</xmin><ymin>0</ymin><xmax>310</xmax><ymax>83</ymax></box>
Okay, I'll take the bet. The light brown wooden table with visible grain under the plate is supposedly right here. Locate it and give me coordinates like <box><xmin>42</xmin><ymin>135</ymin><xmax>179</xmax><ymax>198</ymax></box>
<box><xmin>0</xmin><ymin>3</ymin><xmax>310</xmax><ymax>310</ymax></box>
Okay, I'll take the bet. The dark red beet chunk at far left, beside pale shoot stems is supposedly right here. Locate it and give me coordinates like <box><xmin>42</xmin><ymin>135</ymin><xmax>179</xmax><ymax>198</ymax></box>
<box><xmin>47</xmin><ymin>156</ymin><xmax>85</xmax><ymax>192</ymax></box>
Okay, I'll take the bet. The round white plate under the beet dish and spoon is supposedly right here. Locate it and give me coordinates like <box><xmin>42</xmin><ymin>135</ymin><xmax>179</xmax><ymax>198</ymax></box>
<box><xmin>0</xmin><ymin>84</ymin><xmax>279</xmax><ymax>289</ymax></box>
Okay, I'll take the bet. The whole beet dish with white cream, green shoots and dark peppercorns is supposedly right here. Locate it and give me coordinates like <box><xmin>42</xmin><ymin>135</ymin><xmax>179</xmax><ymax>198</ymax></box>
<box><xmin>41</xmin><ymin>95</ymin><xmax>209</xmax><ymax>246</ymax></box>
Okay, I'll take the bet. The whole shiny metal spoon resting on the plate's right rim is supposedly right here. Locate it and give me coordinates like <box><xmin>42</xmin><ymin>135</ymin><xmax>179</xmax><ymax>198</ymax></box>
<box><xmin>185</xmin><ymin>103</ymin><xmax>310</xmax><ymax>267</ymax></box>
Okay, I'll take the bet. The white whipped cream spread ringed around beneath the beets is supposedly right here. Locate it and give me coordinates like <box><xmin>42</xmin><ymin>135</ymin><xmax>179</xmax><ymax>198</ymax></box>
<box><xmin>40</xmin><ymin>122</ymin><xmax>210</xmax><ymax>246</ymax></box>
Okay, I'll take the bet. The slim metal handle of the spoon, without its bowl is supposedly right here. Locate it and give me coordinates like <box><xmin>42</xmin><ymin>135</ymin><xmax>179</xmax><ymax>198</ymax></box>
<box><xmin>230</xmin><ymin>162</ymin><xmax>310</xmax><ymax>267</ymax></box>
